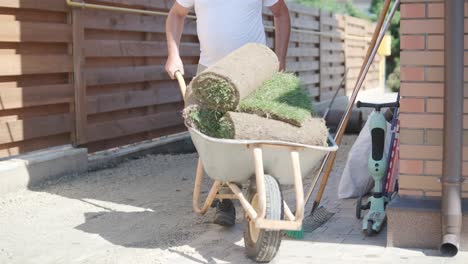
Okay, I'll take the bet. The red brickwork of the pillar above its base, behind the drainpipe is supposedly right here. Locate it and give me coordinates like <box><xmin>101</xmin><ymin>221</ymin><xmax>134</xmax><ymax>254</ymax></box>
<box><xmin>399</xmin><ymin>0</ymin><xmax>468</xmax><ymax>197</ymax></box>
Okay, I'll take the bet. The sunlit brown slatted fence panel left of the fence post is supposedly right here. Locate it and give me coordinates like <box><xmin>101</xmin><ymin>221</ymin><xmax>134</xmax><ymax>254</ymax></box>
<box><xmin>0</xmin><ymin>3</ymin><xmax>74</xmax><ymax>158</ymax></box>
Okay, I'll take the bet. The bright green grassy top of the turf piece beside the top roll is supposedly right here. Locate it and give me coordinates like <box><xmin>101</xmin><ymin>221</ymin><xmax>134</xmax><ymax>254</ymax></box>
<box><xmin>239</xmin><ymin>72</ymin><xmax>313</xmax><ymax>126</ymax></box>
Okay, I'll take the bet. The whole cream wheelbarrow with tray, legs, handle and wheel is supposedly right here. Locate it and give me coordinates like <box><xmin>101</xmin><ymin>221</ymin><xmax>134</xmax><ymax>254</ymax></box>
<box><xmin>175</xmin><ymin>72</ymin><xmax>338</xmax><ymax>262</ymax></box>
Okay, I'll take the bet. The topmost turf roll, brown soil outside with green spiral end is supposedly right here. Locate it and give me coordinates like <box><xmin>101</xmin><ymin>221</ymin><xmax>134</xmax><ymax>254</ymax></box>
<box><xmin>191</xmin><ymin>43</ymin><xmax>279</xmax><ymax>111</ymax></box>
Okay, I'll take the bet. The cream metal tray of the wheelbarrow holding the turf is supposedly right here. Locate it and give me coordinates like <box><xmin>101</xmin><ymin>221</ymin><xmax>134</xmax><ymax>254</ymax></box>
<box><xmin>187</xmin><ymin>126</ymin><xmax>338</xmax><ymax>185</ymax></box>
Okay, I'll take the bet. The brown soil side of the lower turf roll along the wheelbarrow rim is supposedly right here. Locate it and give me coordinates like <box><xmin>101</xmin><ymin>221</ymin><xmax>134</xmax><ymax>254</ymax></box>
<box><xmin>220</xmin><ymin>112</ymin><xmax>328</xmax><ymax>146</ymax></box>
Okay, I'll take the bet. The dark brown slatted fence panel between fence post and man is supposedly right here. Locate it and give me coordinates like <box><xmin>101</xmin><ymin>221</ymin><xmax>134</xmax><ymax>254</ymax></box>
<box><xmin>75</xmin><ymin>0</ymin><xmax>188</xmax><ymax>152</ymax></box>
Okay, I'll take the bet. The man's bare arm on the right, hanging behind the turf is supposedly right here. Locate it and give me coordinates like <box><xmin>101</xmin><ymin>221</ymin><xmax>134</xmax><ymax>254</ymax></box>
<box><xmin>270</xmin><ymin>0</ymin><xmax>291</xmax><ymax>71</ymax></box>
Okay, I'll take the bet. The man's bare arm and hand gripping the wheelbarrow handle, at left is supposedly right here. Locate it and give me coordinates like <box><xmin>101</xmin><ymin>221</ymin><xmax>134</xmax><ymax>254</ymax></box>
<box><xmin>166</xmin><ymin>2</ymin><xmax>189</xmax><ymax>79</ymax></box>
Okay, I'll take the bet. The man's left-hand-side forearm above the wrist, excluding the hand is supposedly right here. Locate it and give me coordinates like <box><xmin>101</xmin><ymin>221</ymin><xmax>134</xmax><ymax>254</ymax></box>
<box><xmin>166</xmin><ymin>12</ymin><xmax>185</xmax><ymax>57</ymax></box>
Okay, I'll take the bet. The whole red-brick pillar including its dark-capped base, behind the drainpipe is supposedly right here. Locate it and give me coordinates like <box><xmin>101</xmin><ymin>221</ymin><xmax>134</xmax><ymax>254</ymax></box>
<box><xmin>387</xmin><ymin>0</ymin><xmax>468</xmax><ymax>251</ymax></box>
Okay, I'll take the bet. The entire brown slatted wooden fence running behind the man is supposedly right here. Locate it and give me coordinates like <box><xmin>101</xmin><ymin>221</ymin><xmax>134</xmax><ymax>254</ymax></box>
<box><xmin>0</xmin><ymin>0</ymin><xmax>378</xmax><ymax>157</ymax></box>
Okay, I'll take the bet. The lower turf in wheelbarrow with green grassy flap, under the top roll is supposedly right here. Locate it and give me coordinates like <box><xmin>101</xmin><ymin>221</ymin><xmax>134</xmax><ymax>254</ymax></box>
<box><xmin>184</xmin><ymin>73</ymin><xmax>328</xmax><ymax>146</ymax></box>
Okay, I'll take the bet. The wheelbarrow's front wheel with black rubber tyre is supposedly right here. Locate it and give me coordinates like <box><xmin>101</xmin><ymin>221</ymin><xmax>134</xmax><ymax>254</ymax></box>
<box><xmin>244</xmin><ymin>175</ymin><xmax>283</xmax><ymax>262</ymax></box>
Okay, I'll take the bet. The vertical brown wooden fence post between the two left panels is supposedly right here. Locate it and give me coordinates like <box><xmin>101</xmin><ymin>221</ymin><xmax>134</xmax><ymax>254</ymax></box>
<box><xmin>72</xmin><ymin>8</ymin><xmax>87</xmax><ymax>146</ymax></box>
